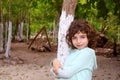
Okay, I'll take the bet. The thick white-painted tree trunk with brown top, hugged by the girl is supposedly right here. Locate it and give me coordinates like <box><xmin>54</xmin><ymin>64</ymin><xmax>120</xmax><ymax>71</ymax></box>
<box><xmin>57</xmin><ymin>0</ymin><xmax>77</xmax><ymax>64</ymax></box>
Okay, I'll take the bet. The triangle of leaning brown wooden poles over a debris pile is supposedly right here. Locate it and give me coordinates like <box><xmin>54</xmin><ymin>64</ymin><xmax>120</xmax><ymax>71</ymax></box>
<box><xmin>28</xmin><ymin>27</ymin><xmax>51</xmax><ymax>52</ymax></box>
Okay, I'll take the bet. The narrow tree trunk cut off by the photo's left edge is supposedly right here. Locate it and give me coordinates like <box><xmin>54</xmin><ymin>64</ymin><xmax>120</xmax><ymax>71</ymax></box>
<box><xmin>0</xmin><ymin>0</ymin><xmax>3</xmax><ymax>52</ymax></box>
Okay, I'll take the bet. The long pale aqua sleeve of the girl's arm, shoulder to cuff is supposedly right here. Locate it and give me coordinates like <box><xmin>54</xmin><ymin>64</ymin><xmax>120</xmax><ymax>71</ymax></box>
<box><xmin>51</xmin><ymin>48</ymin><xmax>97</xmax><ymax>79</ymax></box>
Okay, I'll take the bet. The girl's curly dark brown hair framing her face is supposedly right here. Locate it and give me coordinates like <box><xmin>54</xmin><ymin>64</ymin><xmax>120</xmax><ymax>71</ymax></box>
<box><xmin>66</xmin><ymin>19</ymin><xmax>92</xmax><ymax>49</ymax></box>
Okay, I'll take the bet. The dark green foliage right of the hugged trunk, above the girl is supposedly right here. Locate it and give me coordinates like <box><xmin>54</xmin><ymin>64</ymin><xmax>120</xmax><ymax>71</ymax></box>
<box><xmin>75</xmin><ymin>0</ymin><xmax>120</xmax><ymax>41</ymax></box>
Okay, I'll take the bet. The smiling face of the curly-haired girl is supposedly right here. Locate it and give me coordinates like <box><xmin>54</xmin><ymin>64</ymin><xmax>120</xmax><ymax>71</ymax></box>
<box><xmin>72</xmin><ymin>31</ymin><xmax>88</xmax><ymax>49</ymax></box>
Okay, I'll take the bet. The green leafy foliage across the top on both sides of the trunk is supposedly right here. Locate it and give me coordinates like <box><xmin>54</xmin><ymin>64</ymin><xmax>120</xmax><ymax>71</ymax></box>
<box><xmin>2</xmin><ymin>0</ymin><xmax>120</xmax><ymax>43</ymax></box>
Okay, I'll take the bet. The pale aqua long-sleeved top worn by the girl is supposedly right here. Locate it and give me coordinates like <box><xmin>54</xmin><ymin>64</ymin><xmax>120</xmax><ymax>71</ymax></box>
<box><xmin>51</xmin><ymin>47</ymin><xmax>97</xmax><ymax>80</ymax></box>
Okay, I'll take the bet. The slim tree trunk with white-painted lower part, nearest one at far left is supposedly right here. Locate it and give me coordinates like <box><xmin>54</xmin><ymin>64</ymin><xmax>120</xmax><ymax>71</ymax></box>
<box><xmin>5</xmin><ymin>0</ymin><xmax>12</xmax><ymax>58</ymax></box>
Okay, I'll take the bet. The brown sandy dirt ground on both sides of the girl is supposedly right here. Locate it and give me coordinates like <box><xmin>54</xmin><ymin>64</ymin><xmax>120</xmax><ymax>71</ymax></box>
<box><xmin>0</xmin><ymin>43</ymin><xmax>120</xmax><ymax>80</ymax></box>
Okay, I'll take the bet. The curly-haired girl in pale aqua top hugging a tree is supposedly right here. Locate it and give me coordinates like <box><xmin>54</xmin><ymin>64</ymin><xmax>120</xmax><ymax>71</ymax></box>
<box><xmin>51</xmin><ymin>20</ymin><xmax>97</xmax><ymax>80</ymax></box>
